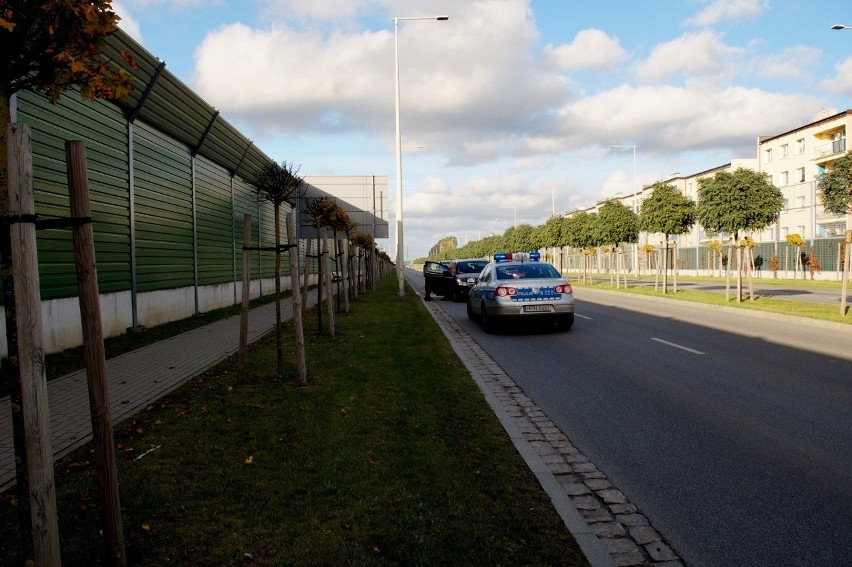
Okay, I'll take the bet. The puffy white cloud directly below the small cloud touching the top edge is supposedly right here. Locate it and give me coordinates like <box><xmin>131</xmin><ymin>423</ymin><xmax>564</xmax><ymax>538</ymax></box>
<box><xmin>636</xmin><ymin>31</ymin><xmax>743</xmax><ymax>82</ymax></box>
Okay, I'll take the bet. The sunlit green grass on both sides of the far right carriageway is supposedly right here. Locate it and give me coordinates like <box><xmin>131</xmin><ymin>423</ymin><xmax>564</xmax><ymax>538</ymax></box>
<box><xmin>571</xmin><ymin>276</ymin><xmax>852</xmax><ymax>325</ymax></box>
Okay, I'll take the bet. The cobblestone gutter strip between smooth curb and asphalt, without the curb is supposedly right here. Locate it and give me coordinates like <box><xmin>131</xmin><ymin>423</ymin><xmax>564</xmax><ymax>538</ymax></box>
<box><xmin>424</xmin><ymin>302</ymin><xmax>684</xmax><ymax>567</ymax></box>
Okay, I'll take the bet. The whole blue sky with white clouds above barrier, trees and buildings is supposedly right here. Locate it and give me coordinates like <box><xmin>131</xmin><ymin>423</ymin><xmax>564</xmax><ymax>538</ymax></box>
<box><xmin>113</xmin><ymin>0</ymin><xmax>852</xmax><ymax>260</ymax></box>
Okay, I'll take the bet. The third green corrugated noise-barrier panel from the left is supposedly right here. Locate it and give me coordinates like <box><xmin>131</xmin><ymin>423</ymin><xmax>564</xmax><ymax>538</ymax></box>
<box><xmin>195</xmin><ymin>157</ymin><xmax>234</xmax><ymax>285</ymax></box>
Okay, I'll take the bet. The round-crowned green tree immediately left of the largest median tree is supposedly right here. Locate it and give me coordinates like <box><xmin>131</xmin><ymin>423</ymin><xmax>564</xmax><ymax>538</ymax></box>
<box><xmin>639</xmin><ymin>182</ymin><xmax>695</xmax><ymax>293</ymax></box>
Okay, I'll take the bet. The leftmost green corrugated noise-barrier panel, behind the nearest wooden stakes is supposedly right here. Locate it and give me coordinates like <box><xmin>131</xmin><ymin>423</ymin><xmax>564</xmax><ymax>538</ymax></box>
<box><xmin>18</xmin><ymin>92</ymin><xmax>130</xmax><ymax>299</ymax></box>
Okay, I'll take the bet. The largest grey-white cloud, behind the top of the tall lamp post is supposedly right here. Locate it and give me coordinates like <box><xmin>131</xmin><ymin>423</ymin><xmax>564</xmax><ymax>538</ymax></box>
<box><xmin>192</xmin><ymin>0</ymin><xmax>567</xmax><ymax>164</ymax></box>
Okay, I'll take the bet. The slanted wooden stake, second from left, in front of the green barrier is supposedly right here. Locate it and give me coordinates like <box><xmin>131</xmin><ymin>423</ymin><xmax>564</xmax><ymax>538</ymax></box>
<box><xmin>65</xmin><ymin>141</ymin><xmax>127</xmax><ymax>566</ymax></box>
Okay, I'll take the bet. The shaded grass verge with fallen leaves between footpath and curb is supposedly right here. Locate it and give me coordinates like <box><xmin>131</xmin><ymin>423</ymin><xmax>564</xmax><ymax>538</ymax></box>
<box><xmin>0</xmin><ymin>278</ymin><xmax>585</xmax><ymax>566</ymax></box>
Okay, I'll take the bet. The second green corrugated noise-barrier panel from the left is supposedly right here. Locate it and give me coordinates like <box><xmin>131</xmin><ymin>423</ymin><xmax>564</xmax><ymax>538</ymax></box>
<box><xmin>133</xmin><ymin>122</ymin><xmax>195</xmax><ymax>292</ymax></box>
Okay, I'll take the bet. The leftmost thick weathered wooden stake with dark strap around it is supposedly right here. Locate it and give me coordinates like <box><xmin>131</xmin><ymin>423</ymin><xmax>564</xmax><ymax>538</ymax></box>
<box><xmin>6</xmin><ymin>124</ymin><xmax>60</xmax><ymax>567</ymax></box>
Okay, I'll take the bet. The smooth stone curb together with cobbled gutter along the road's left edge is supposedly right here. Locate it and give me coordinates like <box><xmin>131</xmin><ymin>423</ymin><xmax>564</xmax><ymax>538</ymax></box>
<box><xmin>421</xmin><ymin>298</ymin><xmax>684</xmax><ymax>567</ymax></box>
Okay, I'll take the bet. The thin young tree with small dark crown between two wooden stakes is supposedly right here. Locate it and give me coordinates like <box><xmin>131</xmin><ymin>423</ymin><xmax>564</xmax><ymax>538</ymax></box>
<box><xmin>252</xmin><ymin>161</ymin><xmax>307</xmax><ymax>385</ymax></box>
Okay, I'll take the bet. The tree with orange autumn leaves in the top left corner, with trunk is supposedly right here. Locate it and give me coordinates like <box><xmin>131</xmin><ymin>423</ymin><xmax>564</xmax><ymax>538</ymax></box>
<box><xmin>0</xmin><ymin>0</ymin><xmax>135</xmax><ymax>564</ymax></box>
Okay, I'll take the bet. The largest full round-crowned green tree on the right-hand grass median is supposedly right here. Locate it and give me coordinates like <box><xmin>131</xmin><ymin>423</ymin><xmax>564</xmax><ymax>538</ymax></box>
<box><xmin>696</xmin><ymin>167</ymin><xmax>784</xmax><ymax>302</ymax></box>
